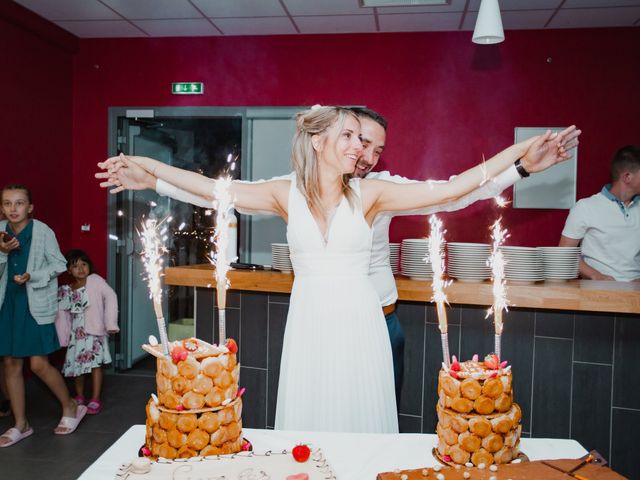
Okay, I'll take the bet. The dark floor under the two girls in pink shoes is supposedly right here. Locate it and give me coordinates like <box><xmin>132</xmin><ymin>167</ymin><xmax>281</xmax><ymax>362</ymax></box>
<box><xmin>0</xmin><ymin>364</ymin><xmax>156</xmax><ymax>480</ymax></box>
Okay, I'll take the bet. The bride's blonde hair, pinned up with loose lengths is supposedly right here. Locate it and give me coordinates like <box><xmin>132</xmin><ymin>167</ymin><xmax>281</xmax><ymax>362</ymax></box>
<box><xmin>291</xmin><ymin>105</ymin><xmax>360</xmax><ymax>218</ymax></box>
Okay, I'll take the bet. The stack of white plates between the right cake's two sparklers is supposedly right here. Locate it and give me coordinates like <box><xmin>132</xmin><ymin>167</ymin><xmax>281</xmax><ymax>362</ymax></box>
<box><xmin>447</xmin><ymin>242</ymin><xmax>491</xmax><ymax>282</ymax></box>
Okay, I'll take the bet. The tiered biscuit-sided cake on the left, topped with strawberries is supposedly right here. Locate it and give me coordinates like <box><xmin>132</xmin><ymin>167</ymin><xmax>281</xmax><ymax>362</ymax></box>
<box><xmin>143</xmin><ymin>338</ymin><xmax>243</xmax><ymax>459</ymax></box>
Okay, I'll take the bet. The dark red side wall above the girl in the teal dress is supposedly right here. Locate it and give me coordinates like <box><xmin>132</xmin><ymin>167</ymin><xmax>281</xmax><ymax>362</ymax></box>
<box><xmin>0</xmin><ymin>2</ymin><xmax>75</xmax><ymax>256</ymax></box>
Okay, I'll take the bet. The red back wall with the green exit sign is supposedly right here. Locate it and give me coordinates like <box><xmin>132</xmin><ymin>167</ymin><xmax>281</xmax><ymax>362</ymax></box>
<box><xmin>67</xmin><ymin>28</ymin><xmax>640</xmax><ymax>274</ymax></box>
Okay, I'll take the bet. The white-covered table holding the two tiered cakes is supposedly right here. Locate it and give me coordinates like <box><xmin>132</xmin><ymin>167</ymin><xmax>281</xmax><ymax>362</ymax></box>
<box><xmin>80</xmin><ymin>425</ymin><xmax>587</xmax><ymax>480</ymax></box>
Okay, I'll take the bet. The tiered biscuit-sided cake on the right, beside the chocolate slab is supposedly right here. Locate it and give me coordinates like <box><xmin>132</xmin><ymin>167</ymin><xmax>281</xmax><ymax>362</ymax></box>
<box><xmin>436</xmin><ymin>354</ymin><xmax>522</xmax><ymax>466</ymax></box>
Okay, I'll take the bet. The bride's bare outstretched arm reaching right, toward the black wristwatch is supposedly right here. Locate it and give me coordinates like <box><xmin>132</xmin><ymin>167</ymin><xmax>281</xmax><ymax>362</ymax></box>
<box><xmin>362</xmin><ymin>126</ymin><xmax>581</xmax><ymax>219</ymax></box>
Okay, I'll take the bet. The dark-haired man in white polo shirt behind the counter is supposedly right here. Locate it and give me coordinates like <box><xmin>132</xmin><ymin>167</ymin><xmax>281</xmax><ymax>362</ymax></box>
<box><xmin>560</xmin><ymin>145</ymin><xmax>640</xmax><ymax>282</ymax></box>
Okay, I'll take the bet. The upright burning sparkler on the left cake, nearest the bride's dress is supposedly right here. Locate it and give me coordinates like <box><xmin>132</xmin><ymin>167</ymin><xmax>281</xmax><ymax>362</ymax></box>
<box><xmin>211</xmin><ymin>176</ymin><xmax>233</xmax><ymax>345</ymax></box>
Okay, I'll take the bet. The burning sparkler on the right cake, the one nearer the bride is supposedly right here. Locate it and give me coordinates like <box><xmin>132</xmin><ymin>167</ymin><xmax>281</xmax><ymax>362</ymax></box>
<box><xmin>429</xmin><ymin>215</ymin><xmax>451</xmax><ymax>368</ymax></box>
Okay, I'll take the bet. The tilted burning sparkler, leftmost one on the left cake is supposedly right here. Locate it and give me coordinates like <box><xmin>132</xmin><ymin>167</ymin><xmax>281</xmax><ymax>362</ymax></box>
<box><xmin>139</xmin><ymin>218</ymin><xmax>169</xmax><ymax>355</ymax></box>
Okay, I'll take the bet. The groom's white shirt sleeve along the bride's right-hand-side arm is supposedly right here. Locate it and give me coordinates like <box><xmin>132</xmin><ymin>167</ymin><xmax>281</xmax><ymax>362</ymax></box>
<box><xmin>367</xmin><ymin>165</ymin><xmax>521</xmax><ymax>216</ymax></box>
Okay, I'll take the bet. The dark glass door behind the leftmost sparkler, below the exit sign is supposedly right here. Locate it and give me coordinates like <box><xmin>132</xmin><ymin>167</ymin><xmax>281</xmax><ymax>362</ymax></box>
<box><xmin>109</xmin><ymin>108</ymin><xmax>244</xmax><ymax>369</ymax></box>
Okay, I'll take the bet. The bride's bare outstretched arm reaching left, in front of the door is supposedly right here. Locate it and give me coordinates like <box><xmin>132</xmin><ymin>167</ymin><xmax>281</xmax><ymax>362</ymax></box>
<box><xmin>96</xmin><ymin>154</ymin><xmax>289</xmax><ymax>219</ymax></box>
